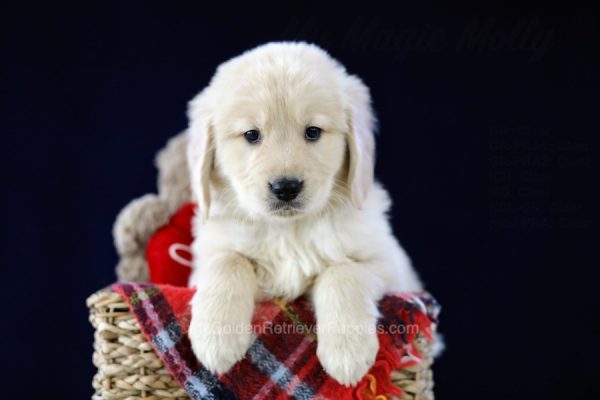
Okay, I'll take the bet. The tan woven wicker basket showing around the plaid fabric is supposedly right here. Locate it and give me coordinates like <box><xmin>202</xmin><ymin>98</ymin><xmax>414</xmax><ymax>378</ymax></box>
<box><xmin>87</xmin><ymin>289</ymin><xmax>433</xmax><ymax>400</ymax></box>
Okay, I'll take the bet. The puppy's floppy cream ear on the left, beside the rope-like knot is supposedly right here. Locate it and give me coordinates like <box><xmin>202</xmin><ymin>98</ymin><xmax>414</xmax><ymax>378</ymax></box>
<box><xmin>187</xmin><ymin>89</ymin><xmax>215</xmax><ymax>223</ymax></box>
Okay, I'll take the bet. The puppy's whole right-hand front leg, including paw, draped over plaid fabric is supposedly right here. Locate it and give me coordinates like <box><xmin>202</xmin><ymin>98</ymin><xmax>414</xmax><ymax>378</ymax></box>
<box><xmin>312</xmin><ymin>262</ymin><xmax>383</xmax><ymax>385</ymax></box>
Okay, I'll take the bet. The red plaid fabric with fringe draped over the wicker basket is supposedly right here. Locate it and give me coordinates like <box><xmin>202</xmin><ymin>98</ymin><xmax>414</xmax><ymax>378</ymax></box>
<box><xmin>113</xmin><ymin>283</ymin><xmax>439</xmax><ymax>400</ymax></box>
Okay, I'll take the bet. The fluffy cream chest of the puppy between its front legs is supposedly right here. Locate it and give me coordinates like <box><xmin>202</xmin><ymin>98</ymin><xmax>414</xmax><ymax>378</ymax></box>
<box><xmin>248</xmin><ymin>228</ymin><xmax>333</xmax><ymax>299</ymax></box>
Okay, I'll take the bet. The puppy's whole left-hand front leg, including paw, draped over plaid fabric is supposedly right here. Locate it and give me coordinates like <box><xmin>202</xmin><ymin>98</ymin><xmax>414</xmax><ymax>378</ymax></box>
<box><xmin>189</xmin><ymin>252</ymin><xmax>256</xmax><ymax>373</ymax></box>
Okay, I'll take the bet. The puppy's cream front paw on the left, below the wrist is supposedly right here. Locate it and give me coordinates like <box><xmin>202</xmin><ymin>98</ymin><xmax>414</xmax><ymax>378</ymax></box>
<box><xmin>188</xmin><ymin>312</ymin><xmax>252</xmax><ymax>374</ymax></box>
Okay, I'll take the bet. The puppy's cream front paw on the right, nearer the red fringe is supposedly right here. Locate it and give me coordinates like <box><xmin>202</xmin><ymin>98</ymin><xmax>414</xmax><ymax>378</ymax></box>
<box><xmin>317</xmin><ymin>324</ymin><xmax>379</xmax><ymax>386</ymax></box>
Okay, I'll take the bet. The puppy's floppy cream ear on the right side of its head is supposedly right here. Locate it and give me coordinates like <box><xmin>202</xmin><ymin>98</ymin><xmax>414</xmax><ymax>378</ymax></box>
<box><xmin>345</xmin><ymin>76</ymin><xmax>376</xmax><ymax>209</ymax></box>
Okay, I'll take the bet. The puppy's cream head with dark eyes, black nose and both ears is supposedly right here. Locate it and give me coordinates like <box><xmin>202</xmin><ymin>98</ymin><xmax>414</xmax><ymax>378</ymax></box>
<box><xmin>188</xmin><ymin>43</ymin><xmax>374</xmax><ymax>220</ymax></box>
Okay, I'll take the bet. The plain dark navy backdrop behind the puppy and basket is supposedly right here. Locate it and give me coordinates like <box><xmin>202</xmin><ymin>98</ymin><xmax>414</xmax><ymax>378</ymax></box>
<box><xmin>0</xmin><ymin>1</ymin><xmax>600</xmax><ymax>400</ymax></box>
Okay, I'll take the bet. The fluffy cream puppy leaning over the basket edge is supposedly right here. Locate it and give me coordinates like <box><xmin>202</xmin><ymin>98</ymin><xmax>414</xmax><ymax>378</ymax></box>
<box><xmin>188</xmin><ymin>43</ymin><xmax>422</xmax><ymax>385</ymax></box>
